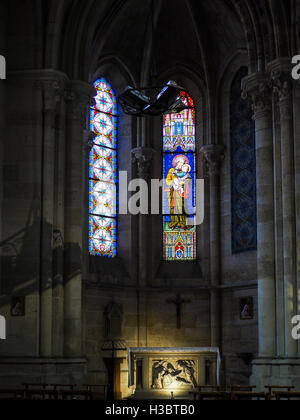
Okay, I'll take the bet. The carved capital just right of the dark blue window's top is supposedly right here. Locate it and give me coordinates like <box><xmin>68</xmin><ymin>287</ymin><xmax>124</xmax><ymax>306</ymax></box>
<box><xmin>242</xmin><ymin>73</ymin><xmax>272</xmax><ymax>120</ymax></box>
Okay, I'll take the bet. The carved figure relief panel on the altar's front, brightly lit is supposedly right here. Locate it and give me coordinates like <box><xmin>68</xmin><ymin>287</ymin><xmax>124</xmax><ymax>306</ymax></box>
<box><xmin>150</xmin><ymin>358</ymin><xmax>198</xmax><ymax>390</ymax></box>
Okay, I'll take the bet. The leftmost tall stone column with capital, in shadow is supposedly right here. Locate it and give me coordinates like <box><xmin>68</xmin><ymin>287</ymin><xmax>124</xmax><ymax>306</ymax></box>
<box><xmin>37</xmin><ymin>72</ymin><xmax>64</xmax><ymax>357</ymax></box>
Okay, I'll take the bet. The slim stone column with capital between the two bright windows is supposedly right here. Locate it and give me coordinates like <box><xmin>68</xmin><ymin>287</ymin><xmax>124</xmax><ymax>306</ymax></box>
<box><xmin>132</xmin><ymin>147</ymin><xmax>155</xmax><ymax>347</ymax></box>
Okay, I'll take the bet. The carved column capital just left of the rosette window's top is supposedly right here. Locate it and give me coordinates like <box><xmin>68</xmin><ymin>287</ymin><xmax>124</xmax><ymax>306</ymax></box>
<box><xmin>66</xmin><ymin>80</ymin><xmax>96</xmax><ymax>127</ymax></box>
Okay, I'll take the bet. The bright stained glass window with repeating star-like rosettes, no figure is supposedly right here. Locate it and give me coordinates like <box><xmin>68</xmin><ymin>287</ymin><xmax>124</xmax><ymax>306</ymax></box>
<box><xmin>89</xmin><ymin>79</ymin><xmax>118</xmax><ymax>258</ymax></box>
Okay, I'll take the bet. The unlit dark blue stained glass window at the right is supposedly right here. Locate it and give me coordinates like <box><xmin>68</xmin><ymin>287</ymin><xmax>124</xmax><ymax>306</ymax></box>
<box><xmin>230</xmin><ymin>67</ymin><xmax>257</xmax><ymax>254</ymax></box>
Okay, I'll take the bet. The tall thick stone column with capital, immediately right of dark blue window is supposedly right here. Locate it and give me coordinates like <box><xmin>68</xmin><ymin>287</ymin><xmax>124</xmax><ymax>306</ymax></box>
<box><xmin>243</xmin><ymin>73</ymin><xmax>276</xmax><ymax>358</ymax></box>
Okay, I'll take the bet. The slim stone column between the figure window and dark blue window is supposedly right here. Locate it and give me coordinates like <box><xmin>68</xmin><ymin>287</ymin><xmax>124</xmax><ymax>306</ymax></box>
<box><xmin>201</xmin><ymin>144</ymin><xmax>225</xmax><ymax>348</ymax></box>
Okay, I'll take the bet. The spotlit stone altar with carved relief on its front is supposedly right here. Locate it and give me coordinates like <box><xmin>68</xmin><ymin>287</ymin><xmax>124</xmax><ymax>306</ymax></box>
<box><xmin>128</xmin><ymin>347</ymin><xmax>221</xmax><ymax>399</ymax></box>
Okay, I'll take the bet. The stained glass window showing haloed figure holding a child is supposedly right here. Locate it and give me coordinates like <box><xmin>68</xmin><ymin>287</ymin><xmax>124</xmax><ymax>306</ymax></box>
<box><xmin>163</xmin><ymin>92</ymin><xmax>196</xmax><ymax>261</ymax></box>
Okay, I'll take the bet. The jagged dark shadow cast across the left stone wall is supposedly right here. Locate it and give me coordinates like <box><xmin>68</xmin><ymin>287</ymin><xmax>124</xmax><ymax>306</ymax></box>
<box><xmin>0</xmin><ymin>200</ymin><xmax>82</xmax><ymax>307</ymax></box>
